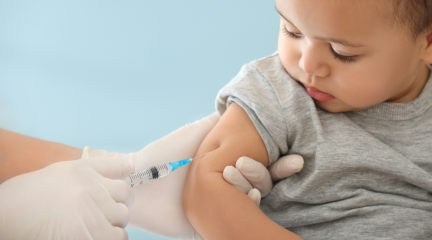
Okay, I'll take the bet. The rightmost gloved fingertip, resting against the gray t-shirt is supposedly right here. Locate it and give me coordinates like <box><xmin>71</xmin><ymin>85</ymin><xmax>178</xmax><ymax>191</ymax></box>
<box><xmin>269</xmin><ymin>154</ymin><xmax>304</xmax><ymax>181</ymax></box>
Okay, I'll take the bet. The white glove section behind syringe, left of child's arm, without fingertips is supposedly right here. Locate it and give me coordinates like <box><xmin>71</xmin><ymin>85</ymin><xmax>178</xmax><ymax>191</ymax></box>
<box><xmin>82</xmin><ymin>113</ymin><xmax>219</xmax><ymax>239</ymax></box>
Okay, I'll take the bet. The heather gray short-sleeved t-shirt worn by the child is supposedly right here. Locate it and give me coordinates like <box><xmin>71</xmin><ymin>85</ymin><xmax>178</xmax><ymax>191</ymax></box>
<box><xmin>216</xmin><ymin>53</ymin><xmax>432</xmax><ymax>240</ymax></box>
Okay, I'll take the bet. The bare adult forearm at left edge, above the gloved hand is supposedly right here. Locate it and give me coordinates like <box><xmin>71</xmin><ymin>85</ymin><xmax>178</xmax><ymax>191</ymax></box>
<box><xmin>0</xmin><ymin>128</ymin><xmax>82</xmax><ymax>183</ymax></box>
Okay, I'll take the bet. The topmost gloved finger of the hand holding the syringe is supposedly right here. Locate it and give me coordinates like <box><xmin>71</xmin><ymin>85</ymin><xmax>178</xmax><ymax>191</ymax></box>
<box><xmin>76</xmin><ymin>158</ymin><xmax>135</xmax><ymax>179</ymax></box>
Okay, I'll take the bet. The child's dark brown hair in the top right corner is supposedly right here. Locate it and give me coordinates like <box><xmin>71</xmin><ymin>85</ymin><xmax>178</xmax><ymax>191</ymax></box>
<box><xmin>386</xmin><ymin>0</ymin><xmax>432</xmax><ymax>40</ymax></box>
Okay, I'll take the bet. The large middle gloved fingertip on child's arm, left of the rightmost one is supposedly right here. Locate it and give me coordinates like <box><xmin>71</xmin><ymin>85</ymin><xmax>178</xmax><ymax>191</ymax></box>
<box><xmin>236</xmin><ymin>157</ymin><xmax>273</xmax><ymax>197</ymax></box>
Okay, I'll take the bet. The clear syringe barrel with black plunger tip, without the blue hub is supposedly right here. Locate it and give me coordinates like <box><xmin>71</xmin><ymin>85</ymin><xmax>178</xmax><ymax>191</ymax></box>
<box><xmin>123</xmin><ymin>163</ymin><xmax>171</xmax><ymax>188</ymax></box>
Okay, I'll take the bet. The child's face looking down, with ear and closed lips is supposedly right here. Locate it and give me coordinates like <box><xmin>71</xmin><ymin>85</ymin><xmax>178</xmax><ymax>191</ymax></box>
<box><xmin>276</xmin><ymin>0</ymin><xmax>429</xmax><ymax>112</ymax></box>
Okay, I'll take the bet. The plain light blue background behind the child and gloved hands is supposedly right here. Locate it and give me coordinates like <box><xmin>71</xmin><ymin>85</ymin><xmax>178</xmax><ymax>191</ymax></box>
<box><xmin>0</xmin><ymin>0</ymin><xmax>279</xmax><ymax>240</ymax></box>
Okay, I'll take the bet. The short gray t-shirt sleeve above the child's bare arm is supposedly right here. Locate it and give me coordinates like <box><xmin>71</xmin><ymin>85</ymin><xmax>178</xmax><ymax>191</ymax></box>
<box><xmin>216</xmin><ymin>64</ymin><xmax>288</xmax><ymax>164</ymax></box>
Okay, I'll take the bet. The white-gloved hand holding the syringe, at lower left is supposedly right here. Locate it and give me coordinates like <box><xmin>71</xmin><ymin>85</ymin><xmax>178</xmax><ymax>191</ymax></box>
<box><xmin>0</xmin><ymin>159</ymin><xmax>134</xmax><ymax>240</ymax></box>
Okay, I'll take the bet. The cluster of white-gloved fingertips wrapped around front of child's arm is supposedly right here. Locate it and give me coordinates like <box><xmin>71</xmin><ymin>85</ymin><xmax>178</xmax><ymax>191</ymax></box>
<box><xmin>223</xmin><ymin>154</ymin><xmax>304</xmax><ymax>206</ymax></box>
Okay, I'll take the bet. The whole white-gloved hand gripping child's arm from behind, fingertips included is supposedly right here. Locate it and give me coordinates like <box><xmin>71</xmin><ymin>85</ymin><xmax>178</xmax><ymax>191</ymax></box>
<box><xmin>83</xmin><ymin>113</ymin><xmax>303</xmax><ymax>239</ymax></box>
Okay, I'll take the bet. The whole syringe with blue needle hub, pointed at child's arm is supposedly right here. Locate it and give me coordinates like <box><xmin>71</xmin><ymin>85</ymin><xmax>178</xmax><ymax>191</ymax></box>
<box><xmin>123</xmin><ymin>153</ymin><xmax>207</xmax><ymax>188</ymax></box>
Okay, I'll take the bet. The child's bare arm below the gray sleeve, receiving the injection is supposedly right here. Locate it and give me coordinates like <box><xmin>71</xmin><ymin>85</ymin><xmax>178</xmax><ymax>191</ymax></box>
<box><xmin>183</xmin><ymin>103</ymin><xmax>302</xmax><ymax>240</ymax></box>
